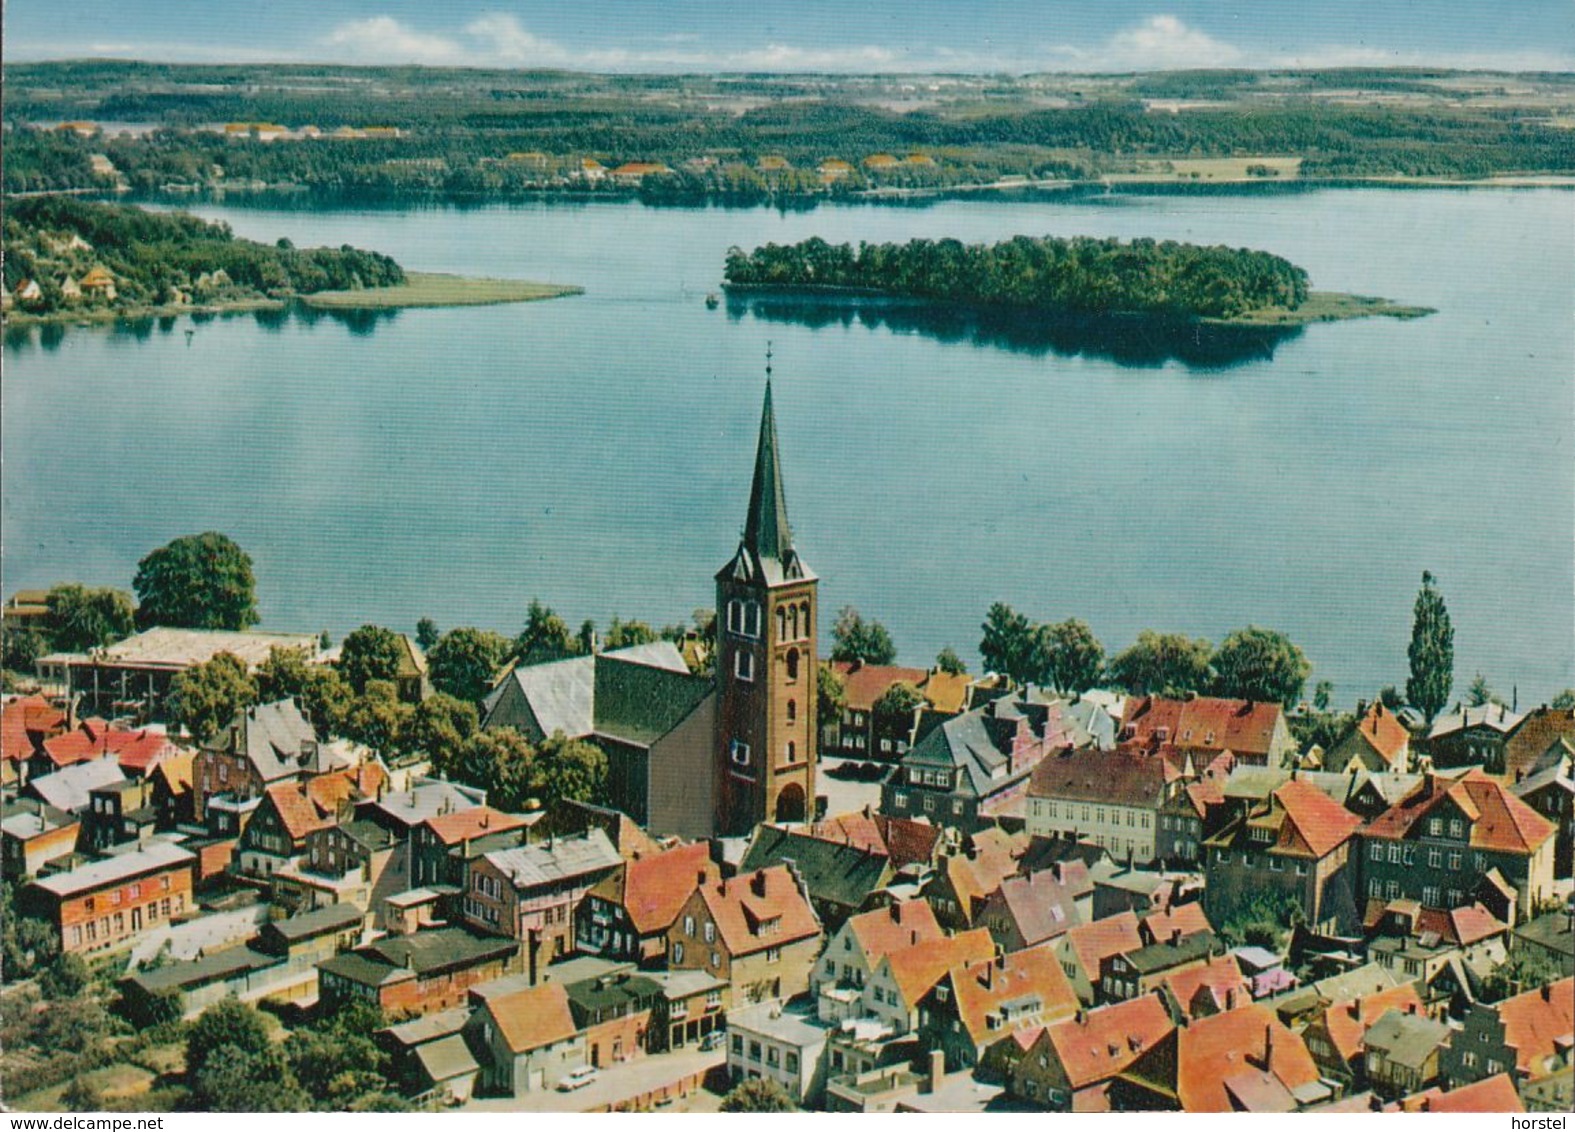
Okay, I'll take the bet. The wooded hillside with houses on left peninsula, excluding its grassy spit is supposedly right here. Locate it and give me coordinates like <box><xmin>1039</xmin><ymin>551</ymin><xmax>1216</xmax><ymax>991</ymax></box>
<box><xmin>5</xmin><ymin>197</ymin><xmax>405</xmax><ymax>315</ymax></box>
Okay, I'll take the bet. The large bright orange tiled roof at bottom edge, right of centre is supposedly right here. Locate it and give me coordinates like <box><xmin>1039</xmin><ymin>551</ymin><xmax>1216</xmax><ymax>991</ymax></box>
<box><xmin>1175</xmin><ymin>1003</ymin><xmax>1318</xmax><ymax>1113</ymax></box>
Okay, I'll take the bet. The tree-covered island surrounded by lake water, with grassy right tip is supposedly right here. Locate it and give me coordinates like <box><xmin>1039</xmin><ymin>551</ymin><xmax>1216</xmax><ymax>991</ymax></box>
<box><xmin>725</xmin><ymin>236</ymin><xmax>1429</xmax><ymax>324</ymax></box>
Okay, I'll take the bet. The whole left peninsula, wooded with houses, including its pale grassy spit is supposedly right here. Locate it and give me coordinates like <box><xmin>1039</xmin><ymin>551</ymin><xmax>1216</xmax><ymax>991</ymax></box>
<box><xmin>5</xmin><ymin>195</ymin><xmax>578</xmax><ymax>320</ymax></box>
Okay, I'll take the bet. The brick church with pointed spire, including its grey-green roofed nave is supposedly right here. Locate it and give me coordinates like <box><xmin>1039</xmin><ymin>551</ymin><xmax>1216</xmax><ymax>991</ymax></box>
<box><xmin>482</xmin><ymin>375</ymin><xmax>819</xmax><ymax>839</ymax></box>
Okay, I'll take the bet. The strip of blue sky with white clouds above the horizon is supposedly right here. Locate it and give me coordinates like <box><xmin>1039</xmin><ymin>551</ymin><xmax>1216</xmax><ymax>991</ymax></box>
<box><xmin>5</xmin><ymin>0</ymin><xmax>1575</xmax><ymax>71</ymax></box>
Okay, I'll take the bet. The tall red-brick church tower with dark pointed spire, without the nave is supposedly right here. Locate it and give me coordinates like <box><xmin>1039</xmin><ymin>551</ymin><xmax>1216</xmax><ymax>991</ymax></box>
<box><xmin>717</xmin><ymin>377</ymin><xmax>819</xmax><ymax>836</ymax></box>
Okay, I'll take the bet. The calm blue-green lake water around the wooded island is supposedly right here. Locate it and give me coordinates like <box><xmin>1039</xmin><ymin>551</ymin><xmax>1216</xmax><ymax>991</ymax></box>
<box><xmin>3</xmin><ymin>191</ymin><xmax>1575</xmax><ymax>705</ymax></box>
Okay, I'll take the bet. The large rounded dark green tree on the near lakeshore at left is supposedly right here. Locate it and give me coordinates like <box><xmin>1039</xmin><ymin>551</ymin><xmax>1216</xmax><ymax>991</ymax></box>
<box><xmin>131</xmin><ymin>531</ymin><xmax>258</xmax><ymax>630</ymax></box>
